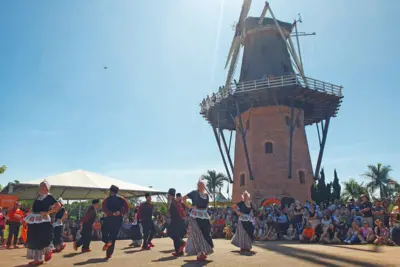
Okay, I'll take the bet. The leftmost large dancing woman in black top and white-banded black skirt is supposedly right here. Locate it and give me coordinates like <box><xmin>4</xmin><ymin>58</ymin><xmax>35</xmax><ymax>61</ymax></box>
<box><xmin>24</xmin><ymin>181</ymin><xmax>61</xmax><ymax>266</ymax></box>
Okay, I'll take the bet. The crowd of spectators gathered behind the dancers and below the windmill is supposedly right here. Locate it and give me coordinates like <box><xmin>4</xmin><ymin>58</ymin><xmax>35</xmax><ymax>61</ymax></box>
<box><xmin>0</xmin><ymin>195</ymin><xmax>400</xmax><ymax>249</ymax></box>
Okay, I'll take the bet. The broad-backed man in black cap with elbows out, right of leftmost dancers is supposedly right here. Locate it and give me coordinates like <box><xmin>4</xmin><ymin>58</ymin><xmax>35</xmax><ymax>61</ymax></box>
<box><xmin>102</xmin><ymin>185</ymin><xmax>129</xmax><ymax>259</ymax></box>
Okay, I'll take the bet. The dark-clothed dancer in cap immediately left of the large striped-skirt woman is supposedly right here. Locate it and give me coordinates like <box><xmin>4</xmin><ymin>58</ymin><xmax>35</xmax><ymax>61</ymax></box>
<box><xmin>167</xmin><ymin>188</ymin><xmax>186</xmax><ymax>257</ymax></box>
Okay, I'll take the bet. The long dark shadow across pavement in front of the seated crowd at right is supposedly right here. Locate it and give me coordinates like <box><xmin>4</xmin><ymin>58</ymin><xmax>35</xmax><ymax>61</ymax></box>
<box><xmin>256</xmin><ymin>242</ymin><xmax>387</xmax><ymax>267</ymax></box>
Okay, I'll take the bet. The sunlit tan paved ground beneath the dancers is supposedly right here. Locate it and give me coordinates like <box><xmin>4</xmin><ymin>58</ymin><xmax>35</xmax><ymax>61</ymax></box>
<box><xmin>0</xmin><ymin>241</ymin><xmax>400</xmax><ymax>267</ymax></box>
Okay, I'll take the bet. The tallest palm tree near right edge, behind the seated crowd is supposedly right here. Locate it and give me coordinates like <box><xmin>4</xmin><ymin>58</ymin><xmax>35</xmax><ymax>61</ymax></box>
<box><xmin>363</xmin><ymin>163</ymin><xmax>392</xmax><ymax>198</ymax></box>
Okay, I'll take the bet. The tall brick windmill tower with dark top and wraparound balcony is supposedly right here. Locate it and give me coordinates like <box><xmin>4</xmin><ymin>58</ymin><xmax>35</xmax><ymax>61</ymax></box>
<box><xmin>200</xmin><ymin>0</ymin><xmax>343</xmax><ymax>202</ymax></box>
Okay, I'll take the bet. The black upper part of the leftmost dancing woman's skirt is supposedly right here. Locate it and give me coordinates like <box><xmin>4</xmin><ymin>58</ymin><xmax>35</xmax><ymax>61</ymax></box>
<box><xmin>28</xmin><ymin>222</ymin><xmax>53</xmax><ymax>250</ymax></box>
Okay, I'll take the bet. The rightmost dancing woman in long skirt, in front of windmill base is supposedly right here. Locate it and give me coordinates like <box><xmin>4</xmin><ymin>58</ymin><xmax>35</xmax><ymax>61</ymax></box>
<box><xmin>232</xmin><ymin>191</ymin><xmax>254</xmax><ymax>252</ymax></box>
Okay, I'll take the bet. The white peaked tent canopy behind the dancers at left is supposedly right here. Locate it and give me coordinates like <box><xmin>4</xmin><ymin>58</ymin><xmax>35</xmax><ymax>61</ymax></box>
<box><xmin>2</xmin><ymin>170</ymin><xmax>165</xmax><ymax>200</ymax></box>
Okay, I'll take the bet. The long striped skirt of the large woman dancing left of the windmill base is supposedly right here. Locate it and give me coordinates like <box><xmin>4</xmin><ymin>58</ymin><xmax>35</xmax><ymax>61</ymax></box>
<box><xmin>185</xmin><ymin>217</ymin><xmax>213</xmax><ymax>256</ymax></box>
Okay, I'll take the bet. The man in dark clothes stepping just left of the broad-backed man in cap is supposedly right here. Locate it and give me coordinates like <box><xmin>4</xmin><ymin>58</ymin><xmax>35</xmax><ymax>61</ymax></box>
<box><xmin>74</xmin><ymin>199</ymin><xmax>100</xmax><ymax>253</ymax></box>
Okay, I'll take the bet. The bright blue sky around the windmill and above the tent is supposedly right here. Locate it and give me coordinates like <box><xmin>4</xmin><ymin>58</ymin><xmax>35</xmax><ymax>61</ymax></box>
<box><xmin>0</xmin><ymin>0</ymin><xmax>400</xmax><ymax>197</ymax></box>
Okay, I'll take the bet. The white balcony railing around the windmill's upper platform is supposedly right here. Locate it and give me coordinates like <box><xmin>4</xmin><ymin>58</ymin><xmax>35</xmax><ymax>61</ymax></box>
<box><xmin>200</xmin><ymin>74</ymin><xmax>343</xmax><ymax>113</ymax></box>
